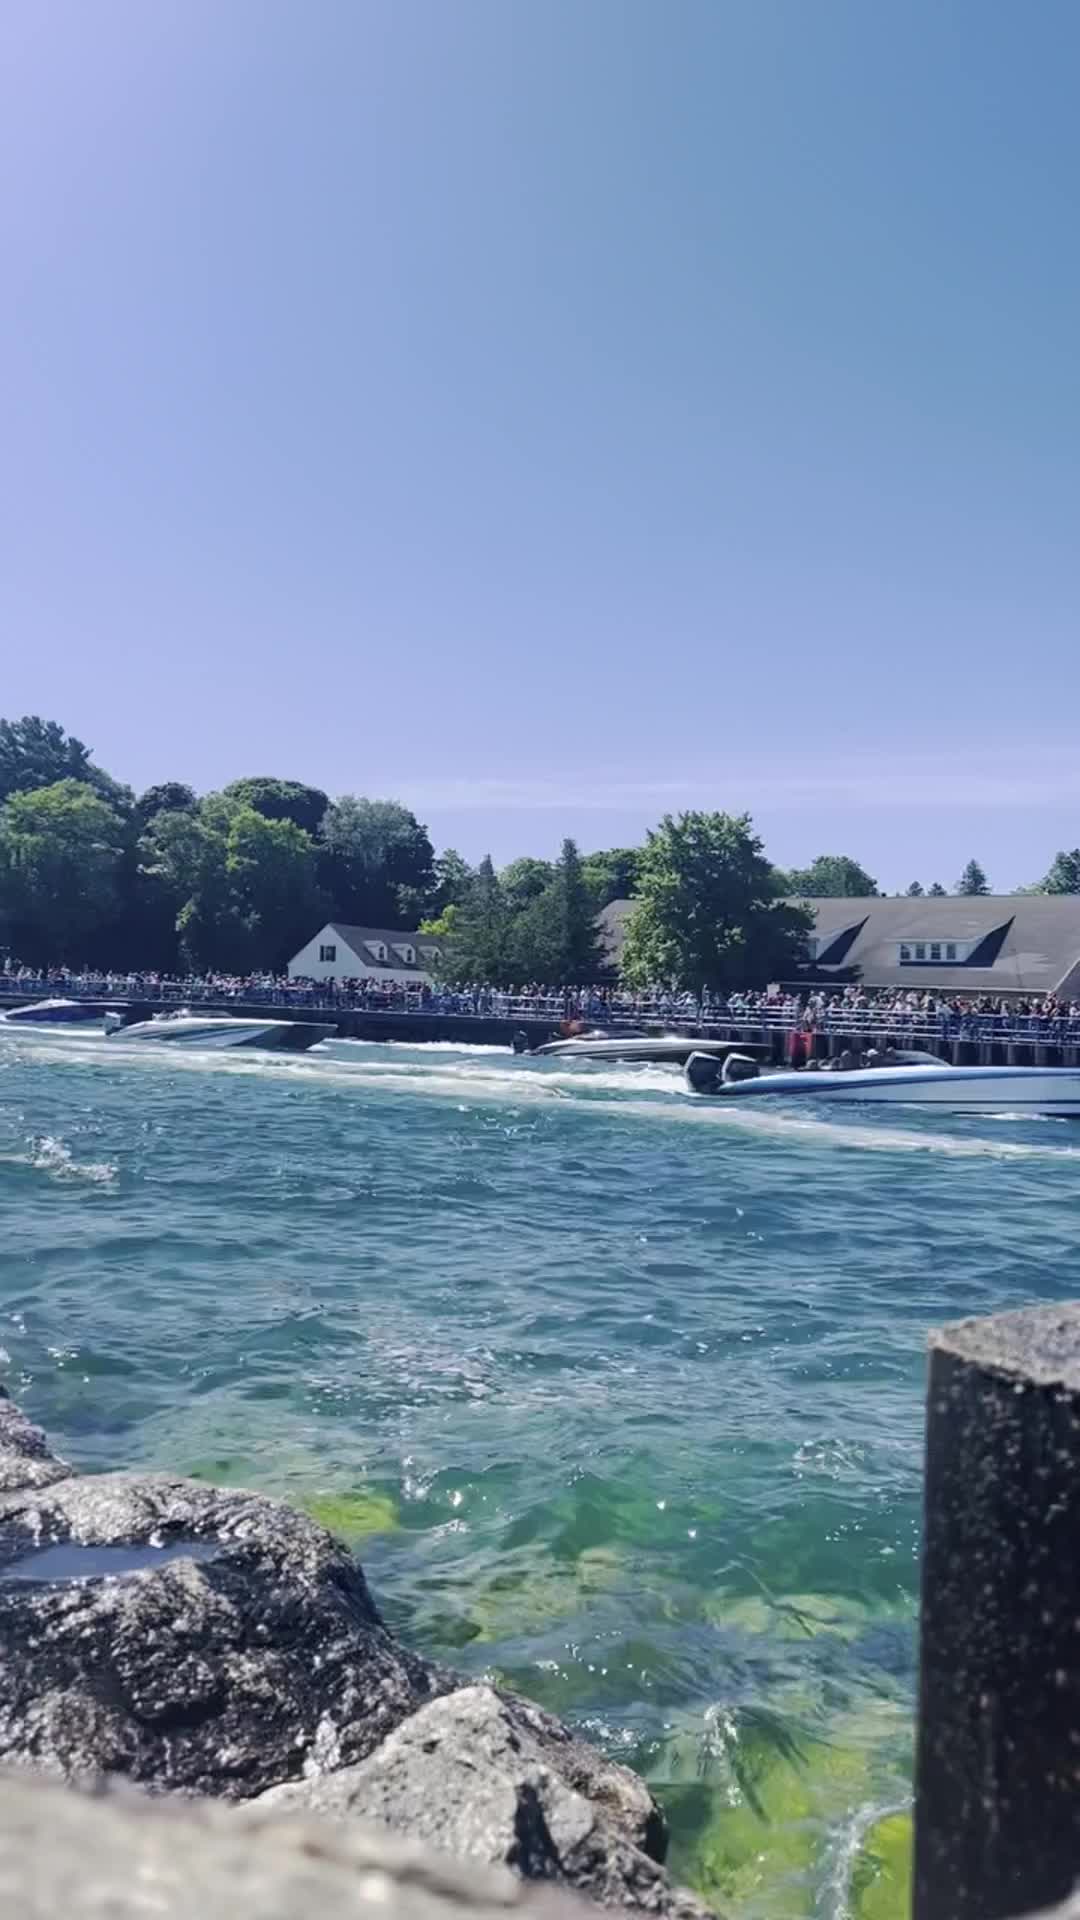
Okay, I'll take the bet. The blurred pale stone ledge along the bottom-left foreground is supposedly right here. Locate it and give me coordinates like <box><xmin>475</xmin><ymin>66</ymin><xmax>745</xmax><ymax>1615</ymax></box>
<box><xmin>0</xmin><ymin>1776</ymin><xmax>607</xmax><ymax>1920</ymax></box>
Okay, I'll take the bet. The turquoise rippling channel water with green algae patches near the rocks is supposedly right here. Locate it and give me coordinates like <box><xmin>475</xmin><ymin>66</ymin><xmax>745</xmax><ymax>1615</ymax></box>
<box><xmin>0</xmin><ymin>1031</ymin><xmax>1080</xmax><ymax>1920</ymax></box>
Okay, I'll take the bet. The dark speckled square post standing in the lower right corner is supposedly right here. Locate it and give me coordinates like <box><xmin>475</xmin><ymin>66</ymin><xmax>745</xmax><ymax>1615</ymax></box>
<box><xmin>915</xmin><ymin>1304</ymin><xmax>1080</xmax><ymax>1920</ymax></box>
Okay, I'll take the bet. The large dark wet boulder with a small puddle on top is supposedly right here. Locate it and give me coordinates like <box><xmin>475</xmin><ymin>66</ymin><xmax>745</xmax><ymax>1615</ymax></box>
<box><xmin>0</xmin><ymin>1455</ymin><xmax>454</xmax><ymax>1799</ymax></box>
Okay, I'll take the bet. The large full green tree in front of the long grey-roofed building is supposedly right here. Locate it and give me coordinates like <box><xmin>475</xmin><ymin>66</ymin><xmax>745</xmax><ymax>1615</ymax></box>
<box><xmin>623</xmin><ymin>812</ymin><xmax>813</xmax><ymax>991</ymax></box>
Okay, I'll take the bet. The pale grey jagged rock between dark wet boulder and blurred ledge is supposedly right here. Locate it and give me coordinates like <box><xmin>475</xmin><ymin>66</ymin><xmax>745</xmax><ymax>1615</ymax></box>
<box><xmin>259</xmin><ymin>1686</ymin><xmax>705</xmax><ymax>1916</ymax></box>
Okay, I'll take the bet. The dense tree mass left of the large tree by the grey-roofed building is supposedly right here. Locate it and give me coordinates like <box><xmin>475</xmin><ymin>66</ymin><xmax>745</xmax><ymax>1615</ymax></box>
<box><xmin>0</xmin><ymin>716</ymin><xmax>636</xmax><ymax>981</ymax></box>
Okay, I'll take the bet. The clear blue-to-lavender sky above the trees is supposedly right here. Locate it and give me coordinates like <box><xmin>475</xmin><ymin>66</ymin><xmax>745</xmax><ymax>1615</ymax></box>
<box><xmin>0</xmin><ymin>0</ymin><xmax>1080</xmax><ymax>887</ymax></box>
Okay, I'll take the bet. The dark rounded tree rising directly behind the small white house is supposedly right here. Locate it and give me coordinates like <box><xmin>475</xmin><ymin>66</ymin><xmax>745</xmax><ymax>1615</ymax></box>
<box><xmin>321</xmin><ymin>793</ymin><xmax>434</xmax><ymax>927</ymax></box>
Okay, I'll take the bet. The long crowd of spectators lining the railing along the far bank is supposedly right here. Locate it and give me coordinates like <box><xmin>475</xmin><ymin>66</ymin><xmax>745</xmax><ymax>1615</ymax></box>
<box><xmin>0</xmin><ymin>960</ymin><xmax>1080</xmax><ymax>1037</ymax></box>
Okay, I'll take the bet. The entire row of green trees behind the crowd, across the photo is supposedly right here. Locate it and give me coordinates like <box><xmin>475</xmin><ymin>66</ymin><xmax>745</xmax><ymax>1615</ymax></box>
<box><xmin>0</xmin><ymin>716</ymin><xmax>1080</xmax><ymax>989</ymax></box>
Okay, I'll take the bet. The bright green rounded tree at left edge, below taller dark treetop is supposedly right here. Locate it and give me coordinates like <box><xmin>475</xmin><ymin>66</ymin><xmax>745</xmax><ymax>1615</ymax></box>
<box><xmin>0</xmin><ymin>780</ymin><xmax>125</xmax><ymax>966</ymax></box>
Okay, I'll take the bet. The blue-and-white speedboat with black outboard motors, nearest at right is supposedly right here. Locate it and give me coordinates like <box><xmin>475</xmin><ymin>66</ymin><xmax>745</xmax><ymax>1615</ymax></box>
<box><xmin>686</xmin><ymin>1052</ymin><xmax>1080</xmax><ymax>1119</ymax></box>
